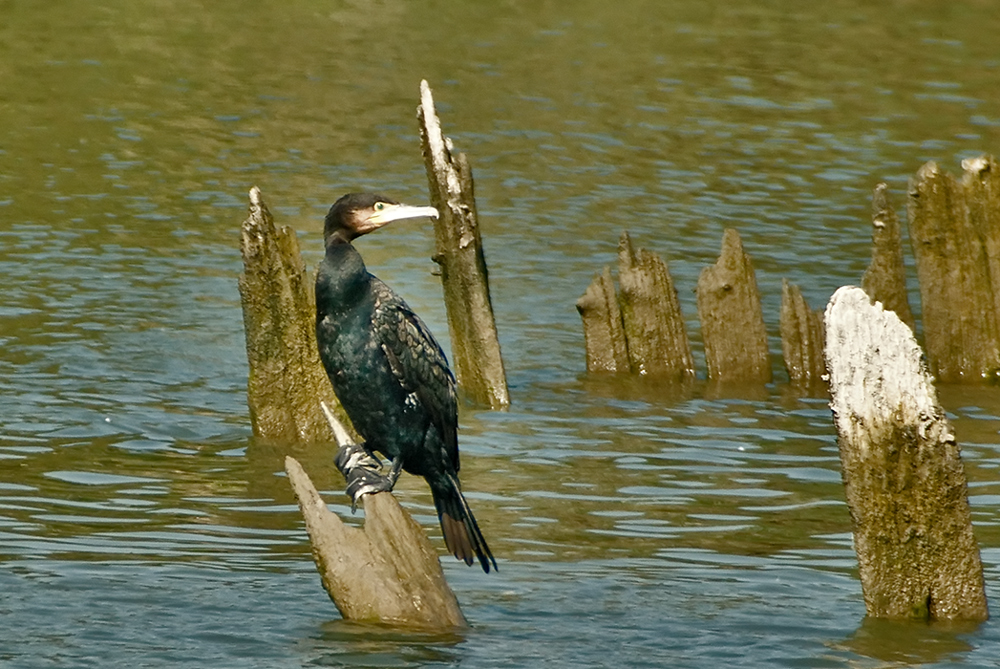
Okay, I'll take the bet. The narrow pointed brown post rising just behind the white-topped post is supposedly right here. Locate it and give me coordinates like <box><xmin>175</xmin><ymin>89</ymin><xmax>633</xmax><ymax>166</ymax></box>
<box><xmin>861</xmin><ymin>183</ymin><xmax>915</xmax><ymax>330</ymax></box>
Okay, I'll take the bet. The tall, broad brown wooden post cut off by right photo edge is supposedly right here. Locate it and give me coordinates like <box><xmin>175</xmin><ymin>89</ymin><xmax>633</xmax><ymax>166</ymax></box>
<box><xmin>908</xmin><ymin>162</ymin><xmax>1000</xmax><ymax>382</ymax></box>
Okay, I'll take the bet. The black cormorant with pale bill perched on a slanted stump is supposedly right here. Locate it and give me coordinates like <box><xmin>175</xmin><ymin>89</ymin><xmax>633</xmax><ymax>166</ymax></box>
<box><xmin>316</xmin><ymin>193</ymin><xmax>496</xmax><ymax>573</ymax></box>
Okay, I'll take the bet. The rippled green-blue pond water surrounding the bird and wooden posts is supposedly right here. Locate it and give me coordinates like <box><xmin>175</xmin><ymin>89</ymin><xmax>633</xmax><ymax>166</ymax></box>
<box><xmin>0</xmin><ymin>0</ymin><xmax>1000</xmax><ymax>668</ymax></box>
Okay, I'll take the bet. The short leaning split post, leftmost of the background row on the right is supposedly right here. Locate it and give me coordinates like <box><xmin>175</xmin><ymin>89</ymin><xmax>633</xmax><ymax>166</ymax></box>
<box><xmin>576</xmin><ymin>267</ymin><xmax>629</xmax><ymax>372</ymax></box>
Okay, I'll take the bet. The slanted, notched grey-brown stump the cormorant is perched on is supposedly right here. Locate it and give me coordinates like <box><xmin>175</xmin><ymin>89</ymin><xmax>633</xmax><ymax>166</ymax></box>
<box><xmin>285</xmin><ymin>404</ymin><xmax>468</xmax><ymax>630</ymax></box>
